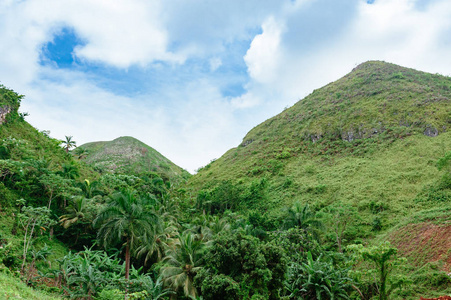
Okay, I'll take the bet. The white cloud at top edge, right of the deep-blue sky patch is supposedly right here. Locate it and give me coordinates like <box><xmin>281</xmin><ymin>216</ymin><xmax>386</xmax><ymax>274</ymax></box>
<box><xmin>61</xmin><ymin>0</ymin><xmax>185</xmax><ymax>68</ymax></box>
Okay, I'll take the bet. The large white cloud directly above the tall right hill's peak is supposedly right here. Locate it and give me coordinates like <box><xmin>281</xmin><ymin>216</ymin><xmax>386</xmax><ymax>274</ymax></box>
<box><xmin>240</xmin><ymin>0</ymin><xmax>451</xmax><ymax>114</ymax></box>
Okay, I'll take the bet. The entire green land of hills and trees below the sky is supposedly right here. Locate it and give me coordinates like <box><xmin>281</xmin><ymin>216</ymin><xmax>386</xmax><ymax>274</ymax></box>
<box><xmin>0</xmin><ymin>62</ymin><xmax>451</xmax><ymax>300</ymax></box>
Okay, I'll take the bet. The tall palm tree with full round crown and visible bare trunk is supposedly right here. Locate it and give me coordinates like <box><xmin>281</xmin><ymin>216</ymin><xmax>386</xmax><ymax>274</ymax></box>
<box><xmin>94</xmin><ymin>191</ymin><xmax>156</xmax><ymax>281</ymax></box>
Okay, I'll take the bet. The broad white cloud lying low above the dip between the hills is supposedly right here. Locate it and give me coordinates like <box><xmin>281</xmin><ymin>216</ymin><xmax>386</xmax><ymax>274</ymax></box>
<box><xmin>21</xmin><ymin>69</ymin><xmax>250</xmax><ymax>172</ymax></box>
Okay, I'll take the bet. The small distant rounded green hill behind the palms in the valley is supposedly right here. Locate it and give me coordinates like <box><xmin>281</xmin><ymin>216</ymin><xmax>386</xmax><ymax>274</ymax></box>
<box><xmin>79</xmin><ymin>136</ymin><xmax>190</xmax><ymax>180</ymax></box>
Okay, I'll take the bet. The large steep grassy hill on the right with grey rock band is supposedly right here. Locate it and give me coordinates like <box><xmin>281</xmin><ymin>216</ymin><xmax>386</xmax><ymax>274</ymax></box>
<box><xmin>188</xmin><ymin>61</ymin><xmax>451</xmax><ymax>262</ymax></box>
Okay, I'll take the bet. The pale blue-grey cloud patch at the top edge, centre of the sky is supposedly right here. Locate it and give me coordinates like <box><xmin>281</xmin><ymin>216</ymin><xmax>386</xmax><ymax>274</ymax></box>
<box><xmin>162</xmin><ymin>0</ymin><xmax>291</xmax><ymax>56</ymax></box>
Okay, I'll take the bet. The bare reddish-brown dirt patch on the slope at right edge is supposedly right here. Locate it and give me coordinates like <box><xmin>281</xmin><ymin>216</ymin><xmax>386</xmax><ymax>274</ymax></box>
<box><xmin>389</xmin><ymin>222</ymin><xmax>451</xmax><ymax>270</ymax></box>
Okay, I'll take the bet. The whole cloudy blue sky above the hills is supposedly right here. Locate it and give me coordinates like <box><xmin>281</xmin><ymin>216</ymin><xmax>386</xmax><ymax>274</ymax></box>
<box><xmin>0</xmin><ymin>0</ymin><xmax>451</xmax><ymax>173</ymax></box>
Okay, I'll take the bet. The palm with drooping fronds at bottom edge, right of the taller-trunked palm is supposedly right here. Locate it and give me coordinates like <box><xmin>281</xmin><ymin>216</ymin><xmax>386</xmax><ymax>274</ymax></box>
<box><xmin>161</xmin><ymin>231</ymin><xmax>205</xmax><ymax>297</ymax></box>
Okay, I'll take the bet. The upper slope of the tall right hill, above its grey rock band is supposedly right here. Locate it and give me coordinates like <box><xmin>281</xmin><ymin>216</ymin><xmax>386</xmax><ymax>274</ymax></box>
<box><xmin>242</xmin><ymin>61</ymin><xmax>451</xmax><ymax>146</ymax></box>
